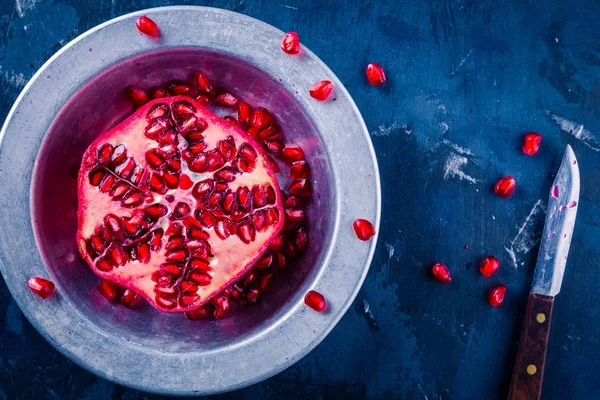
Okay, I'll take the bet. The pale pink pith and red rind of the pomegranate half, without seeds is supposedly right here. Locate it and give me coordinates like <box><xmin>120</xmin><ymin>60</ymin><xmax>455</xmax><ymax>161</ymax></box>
<box><xmin>76</xmin><ymin>96</ymin><xmax>284</xmax><ymax>312</ymax></box>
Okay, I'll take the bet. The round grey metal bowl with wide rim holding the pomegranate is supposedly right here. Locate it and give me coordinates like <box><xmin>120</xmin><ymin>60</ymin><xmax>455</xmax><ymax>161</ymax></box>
<box><xmin>0</xmin><ymin>7</ymin><xmax>381</xmax><ymax>395</ymax></box>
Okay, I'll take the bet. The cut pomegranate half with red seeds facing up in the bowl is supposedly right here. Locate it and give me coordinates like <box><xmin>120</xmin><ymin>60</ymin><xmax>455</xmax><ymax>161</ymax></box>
<box><xmin>77</xmin><ymin>96</ymin><xmax>285</xmax><ymax>315</ymax></box>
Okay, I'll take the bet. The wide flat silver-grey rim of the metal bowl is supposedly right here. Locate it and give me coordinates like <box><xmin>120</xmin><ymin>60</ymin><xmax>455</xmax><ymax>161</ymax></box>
<box><xmin>0</xmin><ymin>6</ymin><xmax>381</xmax><ymax>396</ymax></box>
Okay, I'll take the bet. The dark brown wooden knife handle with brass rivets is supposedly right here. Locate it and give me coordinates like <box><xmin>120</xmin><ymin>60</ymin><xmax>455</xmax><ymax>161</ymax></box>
<box><xmin>508</xmin><ymin>293</ymin><xmax>554</xmax><ymax>400</ymax></box>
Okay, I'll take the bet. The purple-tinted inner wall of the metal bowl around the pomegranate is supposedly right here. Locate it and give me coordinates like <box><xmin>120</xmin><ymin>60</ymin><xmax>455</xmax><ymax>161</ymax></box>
<box><xmin>32</xmin><ymin>48</ymin><xmax>336</xmax><ymax>352</ymax></box>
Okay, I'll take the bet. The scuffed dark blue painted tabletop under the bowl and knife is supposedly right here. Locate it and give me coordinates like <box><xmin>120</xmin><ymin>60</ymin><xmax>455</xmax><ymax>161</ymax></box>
<box><xmin>0</xmin><ymin>0</ymin><xmax>600</xmax><ymax>400</ymax></box>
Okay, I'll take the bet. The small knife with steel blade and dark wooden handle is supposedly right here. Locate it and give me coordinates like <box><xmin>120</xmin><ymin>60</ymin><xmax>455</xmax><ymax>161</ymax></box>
<box><xmin>508</xmin><ymin>146</ymin><xmax>579</xmax><ymax>400</ymax></box>
